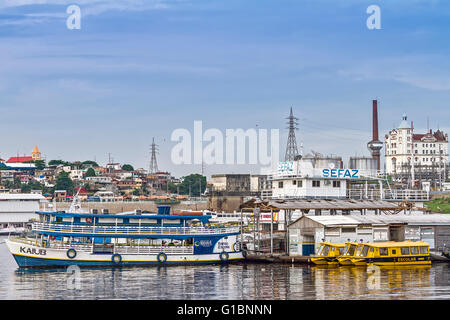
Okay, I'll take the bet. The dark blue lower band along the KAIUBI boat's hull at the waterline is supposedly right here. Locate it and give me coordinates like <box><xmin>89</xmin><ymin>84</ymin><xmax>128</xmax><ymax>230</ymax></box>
<box><xmin>13</xmin><ymin>255</ymin><xmax>243</xmax><ymax>268</ymax></box>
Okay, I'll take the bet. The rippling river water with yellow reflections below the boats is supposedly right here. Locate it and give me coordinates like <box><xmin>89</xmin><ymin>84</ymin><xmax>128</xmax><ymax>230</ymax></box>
<box><xmin>0</xmin><ymin>238</ymin><xmax>450</xmax><ymax>300</ymax></box>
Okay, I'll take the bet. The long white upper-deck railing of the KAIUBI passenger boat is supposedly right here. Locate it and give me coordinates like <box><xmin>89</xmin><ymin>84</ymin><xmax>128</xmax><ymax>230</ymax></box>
<box><xmin>33</xmin><ymin>222</ymin><xmax>239</xmax><ymax>236</ymax></box>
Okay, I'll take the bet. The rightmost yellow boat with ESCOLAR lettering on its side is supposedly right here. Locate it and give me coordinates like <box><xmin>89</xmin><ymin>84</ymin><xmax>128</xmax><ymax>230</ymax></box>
<box><xmin>351</xmin><ymin>241</ymin><xmax>431</xmax><ymax>266</ymax></box>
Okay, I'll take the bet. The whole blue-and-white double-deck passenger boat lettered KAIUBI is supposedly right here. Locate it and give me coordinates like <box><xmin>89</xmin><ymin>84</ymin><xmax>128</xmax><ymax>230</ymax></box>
<box><xmin>6</xmin><ymin>206</ymin><xmax>245</xmax><ymax>267</ymax></box>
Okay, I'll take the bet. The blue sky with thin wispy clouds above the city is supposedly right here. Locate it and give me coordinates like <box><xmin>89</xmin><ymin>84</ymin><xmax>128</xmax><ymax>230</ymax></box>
<box><xmin>0</xmin><ymin>0</ymin><xmax>450</xmax><ymax>176</ymax></box>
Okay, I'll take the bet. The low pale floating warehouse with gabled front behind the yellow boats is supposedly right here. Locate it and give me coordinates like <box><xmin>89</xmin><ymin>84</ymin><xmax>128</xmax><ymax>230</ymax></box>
<box><xmin>288</xmin><ymin>214</ymin><xmax>450</xmax><ymax>255</ymax></box>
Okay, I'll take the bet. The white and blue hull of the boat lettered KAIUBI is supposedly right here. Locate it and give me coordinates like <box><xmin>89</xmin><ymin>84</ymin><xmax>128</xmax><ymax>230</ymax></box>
<box><xmin>5</xmin><ymin>240</ymin><xmax>244</xmax><ymax>268</ymax></box>
